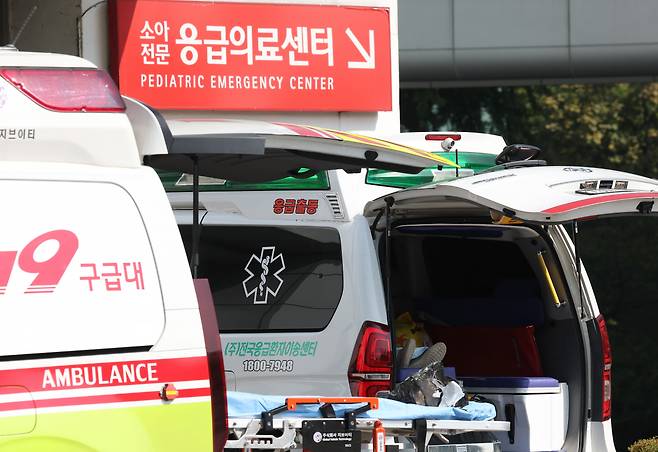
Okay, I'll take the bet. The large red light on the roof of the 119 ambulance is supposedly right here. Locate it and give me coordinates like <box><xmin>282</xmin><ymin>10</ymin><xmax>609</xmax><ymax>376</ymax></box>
<box><xmin>0</xmin><ymin>68</ymin><xmax>126</xmax><ymax>112</ymax></box>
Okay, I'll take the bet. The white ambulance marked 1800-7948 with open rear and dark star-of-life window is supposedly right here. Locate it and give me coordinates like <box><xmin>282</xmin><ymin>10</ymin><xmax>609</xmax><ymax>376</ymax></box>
<box><xmin>161</xmin><ymin>127</ymin><xmax>658</xmax><ymax>452</ymax></box>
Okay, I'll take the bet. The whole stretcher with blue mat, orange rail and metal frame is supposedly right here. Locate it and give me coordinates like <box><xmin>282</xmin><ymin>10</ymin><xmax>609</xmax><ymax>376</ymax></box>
<box><xmin>225</xmin><ymin>392</ymin><xmax>510</xmax><ymax>452</ymax></box>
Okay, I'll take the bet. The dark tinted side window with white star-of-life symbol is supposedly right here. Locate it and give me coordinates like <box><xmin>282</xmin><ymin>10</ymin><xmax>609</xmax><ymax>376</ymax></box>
<box><xmin>181</xmin><ymin>225</ymin><xmax>343</xmax><ymax>332</ymax></box>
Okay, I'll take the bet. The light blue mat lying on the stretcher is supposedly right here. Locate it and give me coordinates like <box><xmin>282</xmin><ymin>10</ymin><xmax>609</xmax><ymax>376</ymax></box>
<box><xmin>227</xmin><ymin>391</ymin><xmax>496</xmax><ymax>421</ymax></box>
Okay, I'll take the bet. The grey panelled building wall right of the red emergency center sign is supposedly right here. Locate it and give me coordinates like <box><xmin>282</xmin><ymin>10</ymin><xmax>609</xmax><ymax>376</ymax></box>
<box><xmin>399</xmin><ymin>0</ymin><xmax>658</xmax><ymax>86</ymax></box>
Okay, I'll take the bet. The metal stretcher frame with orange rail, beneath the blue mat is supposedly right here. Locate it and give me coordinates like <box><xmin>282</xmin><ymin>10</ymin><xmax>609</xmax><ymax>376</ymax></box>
<box><xmin>225</xmin><ymin>397</ymin><xmax>510</xmax><ymax>452</ymax></box>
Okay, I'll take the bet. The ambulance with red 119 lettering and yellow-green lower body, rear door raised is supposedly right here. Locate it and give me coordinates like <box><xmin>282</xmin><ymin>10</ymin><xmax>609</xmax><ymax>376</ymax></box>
<box><xmin>0</xmin><ymin>48</ymin><xmax>454</xmax><ymax>452</ymax></box>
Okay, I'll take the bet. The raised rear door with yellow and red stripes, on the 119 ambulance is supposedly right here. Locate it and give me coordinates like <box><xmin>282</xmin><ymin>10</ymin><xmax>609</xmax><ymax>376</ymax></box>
<box><xmin>129</xmin><ymin>112</ymin><xmax>455</xmax><ymax>182</ymax></box>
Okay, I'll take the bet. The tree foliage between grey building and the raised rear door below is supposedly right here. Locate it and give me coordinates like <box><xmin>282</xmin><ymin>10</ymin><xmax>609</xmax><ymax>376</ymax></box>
<box><xmin>401</xmin><ymin>83</ymin><xmax>658</xmax><ymax>177</ymax></box>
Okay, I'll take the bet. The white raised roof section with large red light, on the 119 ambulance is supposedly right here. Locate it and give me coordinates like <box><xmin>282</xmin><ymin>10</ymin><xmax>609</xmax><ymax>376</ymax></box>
<box><xmin>0</xmin><ymin>47</ymin><xmax>141</xmax><ymax>168</ymax></box>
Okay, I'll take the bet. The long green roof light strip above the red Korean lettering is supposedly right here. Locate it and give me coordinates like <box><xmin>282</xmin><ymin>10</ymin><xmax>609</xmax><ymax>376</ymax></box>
<box><xmin>157</xmin><ymin>168</ymin><xmax>329</xmax><ymax>192</ymax></box>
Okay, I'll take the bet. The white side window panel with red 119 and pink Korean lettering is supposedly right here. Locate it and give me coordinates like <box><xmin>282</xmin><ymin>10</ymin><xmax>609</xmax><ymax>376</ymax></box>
<box><xmin>0</xmin><ymin>180</ymin><xmax>164</xmax><ymax>355</ymax></box>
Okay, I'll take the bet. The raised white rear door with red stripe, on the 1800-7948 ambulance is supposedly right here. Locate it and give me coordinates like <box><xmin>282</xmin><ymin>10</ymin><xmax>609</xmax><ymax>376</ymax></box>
<box><xmin>366</xmin><ymin>166</ymin><xmax>658</xmax><ymax>223</ymax></box>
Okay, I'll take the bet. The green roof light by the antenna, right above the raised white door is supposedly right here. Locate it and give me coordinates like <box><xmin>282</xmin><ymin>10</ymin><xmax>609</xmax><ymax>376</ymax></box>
<box><xmin>366</xmin><ymin>152</ymin><xmax>496</xmax><ymax>188</ymax></box>
